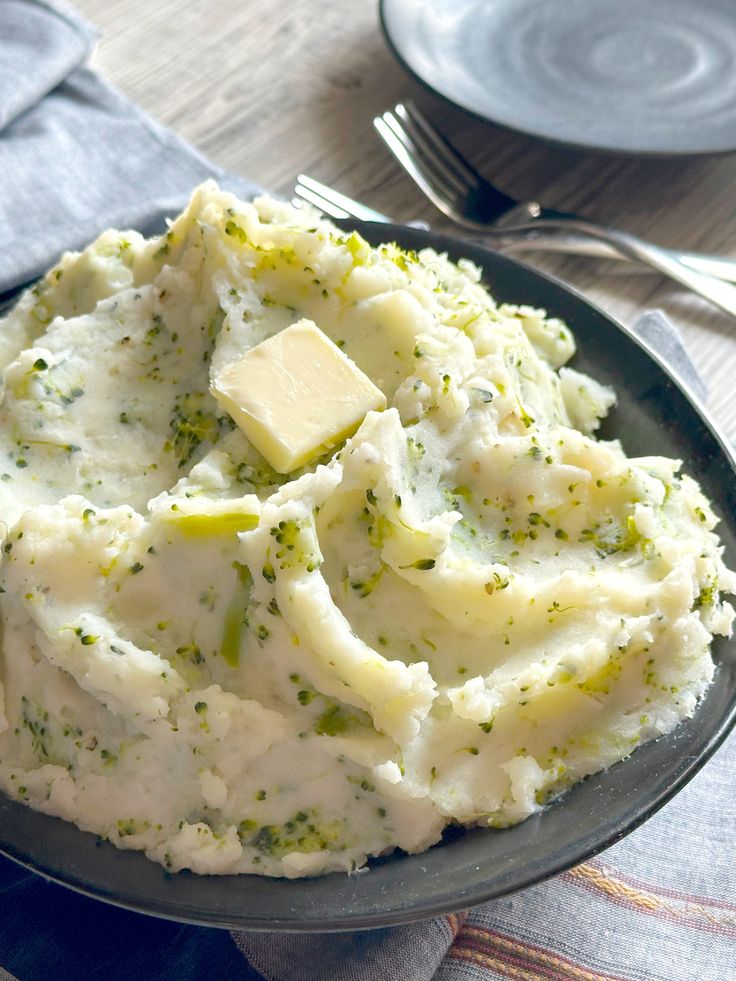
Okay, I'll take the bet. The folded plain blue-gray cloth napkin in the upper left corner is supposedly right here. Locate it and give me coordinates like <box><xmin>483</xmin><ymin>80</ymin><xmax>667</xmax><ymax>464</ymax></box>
<box><xmin>0</xmin><ymin>0</ymin><xmax>258</xmax><ymax>296</ymax></box>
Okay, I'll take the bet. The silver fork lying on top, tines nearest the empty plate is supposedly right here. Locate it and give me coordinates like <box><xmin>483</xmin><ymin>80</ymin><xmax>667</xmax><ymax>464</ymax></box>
<box><xmin>374</xmin><ymin>103</ymin><xmax>736</xmax><ymax>316</ymax></box>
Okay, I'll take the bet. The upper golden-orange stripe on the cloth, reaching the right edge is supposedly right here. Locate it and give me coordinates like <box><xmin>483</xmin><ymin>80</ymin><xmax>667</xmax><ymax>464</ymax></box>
<box><xmin>564</xmin><ymin>863</ymin><xmax>736</xmax><ymax>937</ymax></box>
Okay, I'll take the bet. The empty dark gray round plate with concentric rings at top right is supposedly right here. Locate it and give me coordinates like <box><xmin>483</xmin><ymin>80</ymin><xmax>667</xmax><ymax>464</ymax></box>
<box><xmin>381</xmin><ymin>0</ymin><xmax>736</xmax><ymax>156</ymax></box>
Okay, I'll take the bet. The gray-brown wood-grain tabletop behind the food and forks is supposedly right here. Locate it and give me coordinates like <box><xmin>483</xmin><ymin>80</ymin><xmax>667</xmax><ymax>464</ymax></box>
<box><xmin>76</xmin><ymin>0</ymin><xmax>736</xmax><ymax>440</ymax></box>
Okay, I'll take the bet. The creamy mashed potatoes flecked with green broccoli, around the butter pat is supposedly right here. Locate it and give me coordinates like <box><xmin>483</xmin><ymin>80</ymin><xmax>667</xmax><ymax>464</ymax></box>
<box><xmin>0</xmin><ymin>185</ymin><xmax>735</xmax><ymax>876</ymax></box>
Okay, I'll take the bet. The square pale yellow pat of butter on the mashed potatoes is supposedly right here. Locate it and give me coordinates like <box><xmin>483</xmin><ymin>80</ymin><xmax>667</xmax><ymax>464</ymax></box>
<box><xmin>212</xmin><ymin>320</ymin><xmax>386</xmax><ymax>473</ymax></box>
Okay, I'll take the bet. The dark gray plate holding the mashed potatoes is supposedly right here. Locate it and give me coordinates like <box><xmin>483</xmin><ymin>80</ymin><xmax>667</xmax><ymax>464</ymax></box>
<box><xmin>0</xmin><ymin>223</ymin><xmax>736</xmax><ymax>931</ymax></box>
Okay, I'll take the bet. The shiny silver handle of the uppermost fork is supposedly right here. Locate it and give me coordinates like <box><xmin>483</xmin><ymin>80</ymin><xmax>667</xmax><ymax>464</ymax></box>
<box><xmin>516</xmin><ymin>211</ymin><xmax>736</xmax><ymax>317</ymax></box>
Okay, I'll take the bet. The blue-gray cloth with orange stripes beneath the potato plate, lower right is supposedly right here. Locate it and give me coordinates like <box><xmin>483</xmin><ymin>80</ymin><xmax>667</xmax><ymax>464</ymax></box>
<box><xmin>234</xmin><ymin>724</ymin><xmax>736</xmax><ymax>981</ymax></box>
